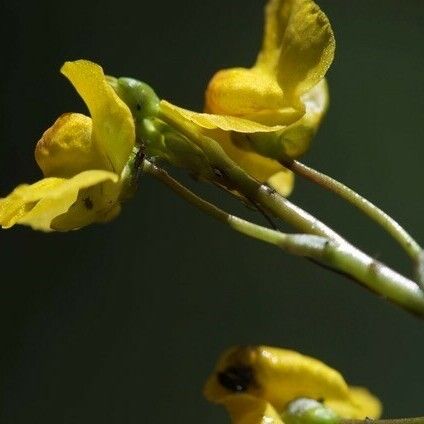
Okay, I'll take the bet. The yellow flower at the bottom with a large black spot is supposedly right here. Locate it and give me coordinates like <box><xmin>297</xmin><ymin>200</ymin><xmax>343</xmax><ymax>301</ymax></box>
<box><xmin>204</xmin><ymin>346</ymin><xmax>381</xmax><ymax>424</ymax></box>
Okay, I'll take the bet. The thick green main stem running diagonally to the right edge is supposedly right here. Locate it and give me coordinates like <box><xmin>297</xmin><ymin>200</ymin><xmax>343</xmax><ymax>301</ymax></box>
<box><xmin>160</xmin><ymin>112</ymin><xmax>424</xmax><ymax>316</ymax></box>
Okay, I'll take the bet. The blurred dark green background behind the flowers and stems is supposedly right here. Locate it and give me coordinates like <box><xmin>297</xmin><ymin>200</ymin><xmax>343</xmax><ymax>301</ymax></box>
<box><xmin>0</xmin><ymin>0</ymin><xmax>424</xmax><ymax>424</ymax></box>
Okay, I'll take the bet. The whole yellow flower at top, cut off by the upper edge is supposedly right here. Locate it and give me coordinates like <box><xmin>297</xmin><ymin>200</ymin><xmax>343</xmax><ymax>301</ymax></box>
<box><xmin>161</xmin><ymin>0</ymin><xmax>335</xmax><ymax>195</ymax></box>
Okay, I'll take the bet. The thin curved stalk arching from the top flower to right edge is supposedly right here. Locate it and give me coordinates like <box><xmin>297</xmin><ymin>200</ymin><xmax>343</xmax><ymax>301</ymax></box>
<box><xmin>282</xmin><ymin>160</ymin><xmax>422</xmax><ymax>262</ymax></box>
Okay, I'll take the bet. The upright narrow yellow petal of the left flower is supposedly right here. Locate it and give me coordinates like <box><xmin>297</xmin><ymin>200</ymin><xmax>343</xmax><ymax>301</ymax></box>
<box><xmin>61</xmin><ymin>60</ymin><xmax>135</xmax><ymax>174</ymax></box>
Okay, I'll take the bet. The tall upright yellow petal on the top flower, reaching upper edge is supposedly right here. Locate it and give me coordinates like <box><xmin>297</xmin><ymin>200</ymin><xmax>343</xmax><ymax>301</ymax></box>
<box><xmin>256</xmin><ymin>0</ymin><xmax>335</xmax><ymax>96</ymax></box>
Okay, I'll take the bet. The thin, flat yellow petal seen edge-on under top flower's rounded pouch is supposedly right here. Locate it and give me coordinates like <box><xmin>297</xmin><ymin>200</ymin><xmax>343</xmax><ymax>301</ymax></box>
<box><xmin>160</xmin><ymin>100</ymin><xmax>285</xmax><ymax>133</ymax></box>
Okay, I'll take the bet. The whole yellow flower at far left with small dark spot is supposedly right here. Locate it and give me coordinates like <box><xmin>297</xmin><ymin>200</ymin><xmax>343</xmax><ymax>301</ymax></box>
<box><xmin>0</xmin><ymin>60</ymin><xmax>135</xmax><ymax>231</ymax></box>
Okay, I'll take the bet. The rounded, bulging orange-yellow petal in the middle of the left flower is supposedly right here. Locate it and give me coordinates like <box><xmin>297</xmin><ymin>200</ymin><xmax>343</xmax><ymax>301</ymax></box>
<box><xmin>35</xmin><ymin>113</ymin><xmax>110</xmax><ymax>178</ymax></box>
